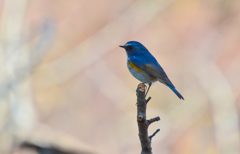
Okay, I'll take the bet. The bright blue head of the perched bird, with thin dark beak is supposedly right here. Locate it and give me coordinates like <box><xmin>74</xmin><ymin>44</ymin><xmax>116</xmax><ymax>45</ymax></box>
<box><xmin>119</xmin><ymin>41</ymin><xmax>148</xmax><ymax>57</ymax></box>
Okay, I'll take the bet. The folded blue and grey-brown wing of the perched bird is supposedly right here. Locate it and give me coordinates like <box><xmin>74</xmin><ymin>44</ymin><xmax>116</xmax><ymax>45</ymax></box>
<box><xmin>130</xmin><ymin>56</ymin><xmax>174</xmax><ymax>88</ymax></box>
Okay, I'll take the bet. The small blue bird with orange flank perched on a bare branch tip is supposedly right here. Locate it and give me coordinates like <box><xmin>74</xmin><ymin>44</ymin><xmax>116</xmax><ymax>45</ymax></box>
<box><xmin>119</xmin><ymin>41</ymin><xmax>184</xmax><ymax>100</ymax></box>
